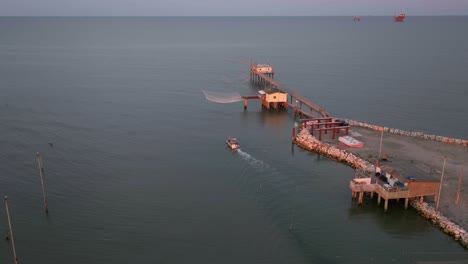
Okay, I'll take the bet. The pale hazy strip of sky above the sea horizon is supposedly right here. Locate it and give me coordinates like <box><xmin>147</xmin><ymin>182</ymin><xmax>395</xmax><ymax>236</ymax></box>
<box><xmin>0</xmin><ymin>0</ymin><xmax>468</xmax><ymax>16</ymax></box>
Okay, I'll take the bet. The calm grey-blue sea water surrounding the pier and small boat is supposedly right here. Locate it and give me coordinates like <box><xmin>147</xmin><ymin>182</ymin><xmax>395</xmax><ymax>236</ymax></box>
<box><xmin>0</xmin><ymin>17</ymin><xmax>468</xmax><ymax>263</ymax></box>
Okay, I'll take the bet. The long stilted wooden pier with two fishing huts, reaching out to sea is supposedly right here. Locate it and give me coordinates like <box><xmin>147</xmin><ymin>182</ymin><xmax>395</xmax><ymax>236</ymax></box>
<box><xmin>247</xmin><ymin>63</ymin><xmax>330</xmax><ymax>118</ymax></box>
